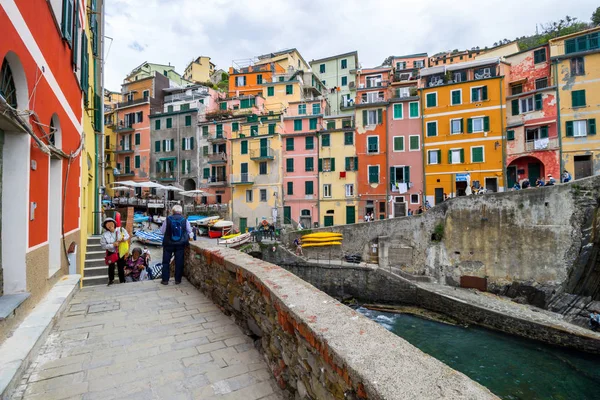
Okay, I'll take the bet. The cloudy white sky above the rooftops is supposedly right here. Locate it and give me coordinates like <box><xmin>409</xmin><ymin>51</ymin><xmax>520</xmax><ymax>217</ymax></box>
<box><xmin>105</xmin><ymin>0</ymin><xmax>599</xmax><ymax>90</ymax></box>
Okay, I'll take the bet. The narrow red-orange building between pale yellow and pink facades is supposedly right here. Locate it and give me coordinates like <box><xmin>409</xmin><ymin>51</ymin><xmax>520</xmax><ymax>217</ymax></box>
<box><xmin>356</xmin><ymin>67</ymin><xmax>393</xmax><ymax>219</ymax></box>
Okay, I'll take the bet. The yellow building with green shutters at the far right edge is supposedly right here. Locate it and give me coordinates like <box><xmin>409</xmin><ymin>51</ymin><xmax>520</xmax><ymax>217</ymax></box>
<box><xmin>550</xmin><ymin>27</ymin><xmax>600</xmax><ymax>179</ymax></box>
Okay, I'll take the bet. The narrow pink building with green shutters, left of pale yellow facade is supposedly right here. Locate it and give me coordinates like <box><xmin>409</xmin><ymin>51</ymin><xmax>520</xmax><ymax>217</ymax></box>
<box><xmin>281</xmin><ymin>99</ymin><xmax>325</xmax><ymax>228</ymax></box>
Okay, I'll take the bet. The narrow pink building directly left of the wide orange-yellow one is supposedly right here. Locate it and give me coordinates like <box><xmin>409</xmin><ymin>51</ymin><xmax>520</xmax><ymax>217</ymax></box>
<box><xmin>386</xmin><ymin>53</ymin><xmax>427</xmax><ymax>217</ymax></box>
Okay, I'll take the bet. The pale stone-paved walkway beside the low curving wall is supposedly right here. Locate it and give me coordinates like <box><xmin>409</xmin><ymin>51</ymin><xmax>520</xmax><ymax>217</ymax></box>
<box><xmin>13</xmin><ymin>280</ymin><xmax>284</xmax><ymax>400</ymax></box>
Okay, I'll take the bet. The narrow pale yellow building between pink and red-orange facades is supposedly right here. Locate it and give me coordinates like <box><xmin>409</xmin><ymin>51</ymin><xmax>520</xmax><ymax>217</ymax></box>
<box><xmin>318</xmin><ymin>115</ymin><xmax>362</xmax><ymax>225</ymax></box>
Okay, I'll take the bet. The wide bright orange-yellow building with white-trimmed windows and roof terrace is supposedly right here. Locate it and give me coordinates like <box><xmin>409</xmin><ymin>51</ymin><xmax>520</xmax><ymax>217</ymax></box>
<box><xmin>420</xmin><ymin>58</ymin><xmax>508</xmax><ymax>206</ymax></box>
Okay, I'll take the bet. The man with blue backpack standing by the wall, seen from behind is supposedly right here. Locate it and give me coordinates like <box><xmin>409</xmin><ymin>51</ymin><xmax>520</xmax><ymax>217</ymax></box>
<box><xmin>160</xmin><ymin>205</ymin><xmax>193</xmax><ymax>285</ymax></box>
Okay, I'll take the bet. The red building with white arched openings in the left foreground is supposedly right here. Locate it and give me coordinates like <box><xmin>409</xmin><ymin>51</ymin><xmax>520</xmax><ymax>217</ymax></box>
<box><xmin>0</xmin><ymin>0</ymin><xmax>85</xmax><ymax>298</ymax></box>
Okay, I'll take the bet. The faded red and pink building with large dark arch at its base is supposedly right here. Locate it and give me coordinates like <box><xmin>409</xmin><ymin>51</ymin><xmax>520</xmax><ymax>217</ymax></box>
<box><xmin>506</xmin><ymin>45</ymin><xmax>561</xmax><ymax>189</ymax></box>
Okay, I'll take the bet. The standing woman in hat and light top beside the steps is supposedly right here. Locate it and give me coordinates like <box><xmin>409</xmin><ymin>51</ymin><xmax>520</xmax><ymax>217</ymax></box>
<box><xmin>100</xmin><ymin>218</ymin><xmax>129</xmax><ymax>286</ymax></box>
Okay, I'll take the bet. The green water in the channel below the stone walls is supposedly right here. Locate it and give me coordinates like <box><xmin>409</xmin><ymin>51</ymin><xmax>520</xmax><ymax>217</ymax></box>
<box><xmin>358</xmin><ymin>308</ymin><xmax>600</xmax><ymax>400</ymax></box>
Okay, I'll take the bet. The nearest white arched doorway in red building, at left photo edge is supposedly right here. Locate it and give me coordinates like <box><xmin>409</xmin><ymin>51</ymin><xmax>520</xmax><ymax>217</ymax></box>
<box><xmin>0</xmin><ymin>52</ymin><xmax>29</xmax><ymax>294</ymax></box>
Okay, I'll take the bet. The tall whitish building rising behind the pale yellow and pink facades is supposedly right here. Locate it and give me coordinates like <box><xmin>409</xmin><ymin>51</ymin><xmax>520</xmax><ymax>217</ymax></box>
<box><xmin>310</xmin><ymin>51</ymin><xmax>359</xmax><ymax>115</ymax></box>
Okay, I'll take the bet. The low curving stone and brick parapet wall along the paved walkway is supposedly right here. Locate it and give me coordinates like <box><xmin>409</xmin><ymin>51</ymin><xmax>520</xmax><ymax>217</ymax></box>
<box><xmin>185</xmin><ymin>244</ymin><xmax>495</xmax><ymax>400</ymax></box>
